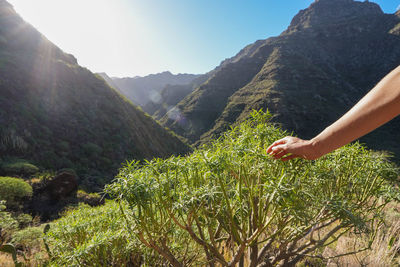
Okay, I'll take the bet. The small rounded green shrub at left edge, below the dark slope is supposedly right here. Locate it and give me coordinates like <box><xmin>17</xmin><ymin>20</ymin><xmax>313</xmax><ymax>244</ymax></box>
<box><xmin>0</xmin><ymin>177</ymin><xmax>32</xmax><ymax>209</ymax></box>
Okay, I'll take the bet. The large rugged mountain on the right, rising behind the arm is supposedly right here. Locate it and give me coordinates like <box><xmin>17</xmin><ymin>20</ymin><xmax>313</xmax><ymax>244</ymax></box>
<box><xmin>161</xmin><ymin>0</ymin><xmax>400</xmax><ymax>159</ymax></box>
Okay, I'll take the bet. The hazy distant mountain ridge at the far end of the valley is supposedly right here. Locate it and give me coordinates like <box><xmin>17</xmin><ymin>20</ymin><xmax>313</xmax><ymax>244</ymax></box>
<box><xmin>112</xmin><ymin>71</ymin><xmax>200</xmax><ymax>107</ymax></box>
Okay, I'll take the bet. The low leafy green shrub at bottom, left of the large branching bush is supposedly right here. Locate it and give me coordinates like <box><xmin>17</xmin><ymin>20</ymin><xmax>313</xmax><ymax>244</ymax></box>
<box><xmin>45</xmin><ymin>201</ymin><xmax>150</xmax><ymax>266</ymax></box>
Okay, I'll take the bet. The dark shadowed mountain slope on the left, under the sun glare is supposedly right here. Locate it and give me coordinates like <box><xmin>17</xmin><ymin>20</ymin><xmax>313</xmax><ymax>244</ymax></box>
<box><xmin>0</xmin><ymin>0</ymin><xmax>190</xmax><ymax>188</ymax></box>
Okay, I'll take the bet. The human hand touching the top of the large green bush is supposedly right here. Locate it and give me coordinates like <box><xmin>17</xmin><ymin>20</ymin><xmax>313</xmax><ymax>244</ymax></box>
<box><xmin>267</xmin><ymin>136</ymin><xmax>322</xmax><ymax>161</ymax></box>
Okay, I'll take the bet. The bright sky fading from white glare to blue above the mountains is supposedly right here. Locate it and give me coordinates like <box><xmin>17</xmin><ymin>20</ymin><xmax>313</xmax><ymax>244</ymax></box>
<box><xmin>9</xmin><ymin>0</ymin><xmax>400</xmax><ymax>77</ymax></box>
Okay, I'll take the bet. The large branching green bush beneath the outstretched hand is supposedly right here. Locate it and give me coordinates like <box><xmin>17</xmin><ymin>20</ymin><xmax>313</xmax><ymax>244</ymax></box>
<box><xmin>106</xmin><ymin>111</ymin><xmax>397</xmax><ymax>266</ymax></box>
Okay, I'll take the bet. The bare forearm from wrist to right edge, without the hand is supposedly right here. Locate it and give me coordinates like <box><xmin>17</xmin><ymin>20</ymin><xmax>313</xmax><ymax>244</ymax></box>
<box><xmin>311</xmin><ymin>66</ymin><xmax>400</xmax><ymax>155</ymax></box>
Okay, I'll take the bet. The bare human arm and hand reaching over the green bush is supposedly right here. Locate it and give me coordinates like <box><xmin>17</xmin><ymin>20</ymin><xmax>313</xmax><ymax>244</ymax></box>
<box><xmin>267</xmin><ymin>66</ymin><xmax>400</xmax><ymax>160</ymax></box>
